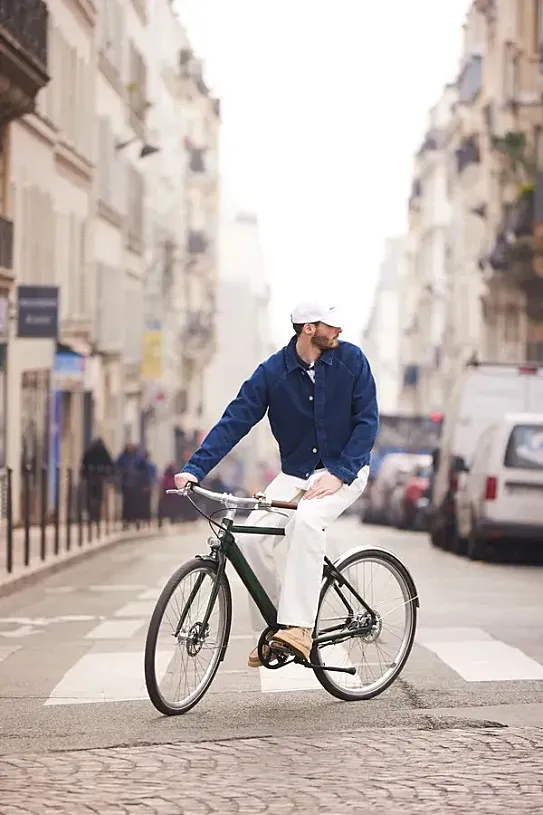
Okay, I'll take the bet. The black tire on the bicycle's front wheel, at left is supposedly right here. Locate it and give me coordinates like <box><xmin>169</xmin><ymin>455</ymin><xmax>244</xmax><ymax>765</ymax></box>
<box><xmin>144</xmin><ymin>558</ymin><xmax>232</xmax><ymax>716</ymax></box>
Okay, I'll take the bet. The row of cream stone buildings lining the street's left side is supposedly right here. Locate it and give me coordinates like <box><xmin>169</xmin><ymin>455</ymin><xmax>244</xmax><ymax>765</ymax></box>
<box><xmin>0</xmin><ymin>0</ymin><xmax>220</xmax><ymax>520</ymax></box>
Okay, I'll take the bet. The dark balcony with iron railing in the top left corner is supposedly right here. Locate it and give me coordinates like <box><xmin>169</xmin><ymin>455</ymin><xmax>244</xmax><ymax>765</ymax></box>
<box><xmin>0</xmin><ymin>0</ymin><xmax>49</xmax><ymax>123</ymax></box>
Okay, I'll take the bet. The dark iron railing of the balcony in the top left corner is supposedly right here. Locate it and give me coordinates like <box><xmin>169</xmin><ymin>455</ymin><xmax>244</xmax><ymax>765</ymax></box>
<box><xmin>0</xmin><ymin>0</ymin><xmax>49</xmax><ymax>69</ymax></box>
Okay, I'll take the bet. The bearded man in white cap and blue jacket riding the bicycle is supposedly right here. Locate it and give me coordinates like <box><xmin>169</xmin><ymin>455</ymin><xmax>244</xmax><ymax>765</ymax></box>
<box><xmin>176</xmin><ymin>303</ymin><xmax>379</xmax><ymax>667</ymax></box>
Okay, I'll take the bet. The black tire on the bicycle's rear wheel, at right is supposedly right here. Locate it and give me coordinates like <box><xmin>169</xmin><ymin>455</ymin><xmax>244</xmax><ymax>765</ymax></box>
<box><xmin>311</xmin><ymin>549</ymin><xmax>418</xmax><ymax>702</ymax></box>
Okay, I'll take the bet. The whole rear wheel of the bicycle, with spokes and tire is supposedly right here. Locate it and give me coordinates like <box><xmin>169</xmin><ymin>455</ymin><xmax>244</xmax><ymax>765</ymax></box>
<box><xmin>312</xmin><ymin>549</ymin><xmax>417</xmax><ymax>702</ymax></box>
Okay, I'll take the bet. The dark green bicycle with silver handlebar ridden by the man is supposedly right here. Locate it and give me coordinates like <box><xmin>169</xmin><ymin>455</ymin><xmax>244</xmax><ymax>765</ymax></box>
<box><xmin>144</xmin><ymin>484</ymin><xmax>419</xmax><ymax>716</ymax></box>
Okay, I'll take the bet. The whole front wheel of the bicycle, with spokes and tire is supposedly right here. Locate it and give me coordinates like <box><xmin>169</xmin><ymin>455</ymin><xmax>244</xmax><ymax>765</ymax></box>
<box><xmin>145</xmin><ymin>558</ymin><xmax>232</xmax><ymax>716</ymax></box>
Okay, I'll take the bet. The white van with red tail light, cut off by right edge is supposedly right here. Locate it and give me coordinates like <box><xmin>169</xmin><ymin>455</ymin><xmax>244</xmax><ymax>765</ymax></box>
<box><xmin>456</xmin><ymin>413</ymin><xmax>543</xmax><ymax>558</ymax></box>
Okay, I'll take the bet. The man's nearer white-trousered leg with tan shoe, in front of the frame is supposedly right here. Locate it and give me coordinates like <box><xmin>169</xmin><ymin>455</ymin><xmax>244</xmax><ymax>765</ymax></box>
<box><xmin>277</xmin><ymin>467</ymin><xmax>368</xmax><ymax>659</ymax></box>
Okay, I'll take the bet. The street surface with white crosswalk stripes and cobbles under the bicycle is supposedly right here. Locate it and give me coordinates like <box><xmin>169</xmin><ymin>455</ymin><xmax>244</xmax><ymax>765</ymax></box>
<box><xmin>0</xmin><ymin>519</ymin><xmax>543</xmax><ymax>815</ymax></box>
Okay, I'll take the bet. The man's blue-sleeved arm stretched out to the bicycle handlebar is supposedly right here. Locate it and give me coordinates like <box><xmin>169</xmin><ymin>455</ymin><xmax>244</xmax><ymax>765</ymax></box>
<box><xmin>182</xmin><ymin>365</ymin><xmax>268</xmax><ymax>481</ymax></box>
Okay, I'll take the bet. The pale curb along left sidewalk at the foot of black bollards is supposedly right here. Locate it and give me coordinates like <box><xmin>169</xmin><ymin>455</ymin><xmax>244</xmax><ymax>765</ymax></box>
<box><xmin>0</xmin><ymin>521</ymin><xmax>203</xmax><ymax>598</ymax></box>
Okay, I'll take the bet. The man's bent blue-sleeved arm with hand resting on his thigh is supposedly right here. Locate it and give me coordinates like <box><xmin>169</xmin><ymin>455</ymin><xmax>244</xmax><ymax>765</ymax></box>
<box><xmin>328</xmin><ymin>352</ymin><xmax>379</xmax><ymax>484</ymax></box>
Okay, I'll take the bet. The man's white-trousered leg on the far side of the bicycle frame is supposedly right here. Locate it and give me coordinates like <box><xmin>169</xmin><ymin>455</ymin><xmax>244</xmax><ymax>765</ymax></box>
<box><xmin>237</xmin><ymin>473</ymin><xmax>302</xmax><ymax>667</ymax></box>
